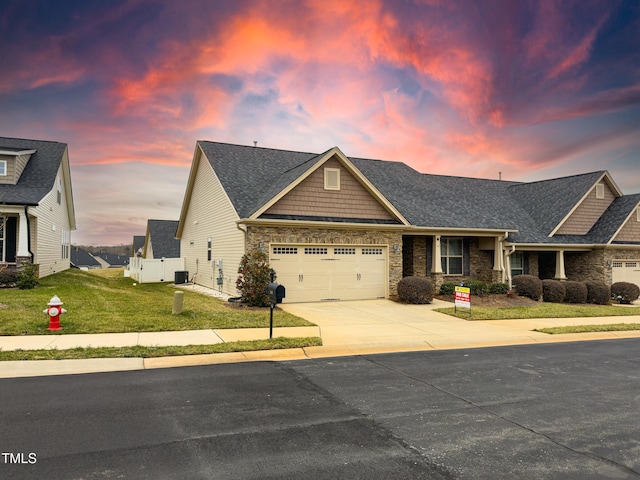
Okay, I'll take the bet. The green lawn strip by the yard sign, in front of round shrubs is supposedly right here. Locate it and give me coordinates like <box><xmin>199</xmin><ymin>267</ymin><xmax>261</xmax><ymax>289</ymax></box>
<box><xmin>435</xmin><ymin>298</ymin><xmax>640</xmax><ymax>320</ymax></box>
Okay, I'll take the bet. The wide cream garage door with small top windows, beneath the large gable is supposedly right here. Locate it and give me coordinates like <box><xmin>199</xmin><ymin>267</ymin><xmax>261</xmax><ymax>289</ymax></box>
<box><xmin>270</xmin><ymin>244</ymin><xmax>387</xmax><ymax>302</ymax></box>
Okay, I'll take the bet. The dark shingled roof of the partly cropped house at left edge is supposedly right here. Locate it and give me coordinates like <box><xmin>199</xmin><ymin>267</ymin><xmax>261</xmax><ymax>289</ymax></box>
<box><xmin>0</xmin><ymin>137</ymin><xmax>67</xmax><ymax>205</ymax></box>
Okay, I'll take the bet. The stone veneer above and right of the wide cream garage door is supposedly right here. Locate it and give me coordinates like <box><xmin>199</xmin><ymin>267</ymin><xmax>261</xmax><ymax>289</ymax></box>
<box><xmin>246</xmin><ymin>225</ymin><xmax>402</xmax><ymax>295</ymax></box>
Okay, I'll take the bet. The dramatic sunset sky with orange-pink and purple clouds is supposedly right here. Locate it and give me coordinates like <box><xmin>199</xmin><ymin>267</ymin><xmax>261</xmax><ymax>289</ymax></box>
<box><xmin>0</xmin><ymin>0</ymin><xmax>640</xmax><ymax>245</ymax></box>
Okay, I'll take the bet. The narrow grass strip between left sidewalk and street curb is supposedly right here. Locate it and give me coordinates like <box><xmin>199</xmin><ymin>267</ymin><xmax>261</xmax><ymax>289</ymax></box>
<box><xmin>0</xmin><ymin>337</ymin><xmax>322</xmax><ymax>361</ymax></box>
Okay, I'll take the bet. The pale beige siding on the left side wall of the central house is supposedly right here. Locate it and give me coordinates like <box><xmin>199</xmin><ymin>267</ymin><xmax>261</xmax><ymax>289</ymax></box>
<box><xmin>180</xmin><ymin>150</ymin><xmax>244</xmax><ymax>295</ymax></box>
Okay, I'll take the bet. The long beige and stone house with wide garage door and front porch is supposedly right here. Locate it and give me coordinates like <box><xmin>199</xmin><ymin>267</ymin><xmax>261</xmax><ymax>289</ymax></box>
<box><xmin>176</xmin><ymin>141</ymin><xmax>640</xmax><ymax>302</ymax></box>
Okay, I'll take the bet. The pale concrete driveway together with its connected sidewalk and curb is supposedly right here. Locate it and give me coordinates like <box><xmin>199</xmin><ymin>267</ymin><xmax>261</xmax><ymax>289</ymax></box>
<box><xmin>0</xmin><ymin>300</ymin><xmax>640</xmax><ymax>378</ymax></box>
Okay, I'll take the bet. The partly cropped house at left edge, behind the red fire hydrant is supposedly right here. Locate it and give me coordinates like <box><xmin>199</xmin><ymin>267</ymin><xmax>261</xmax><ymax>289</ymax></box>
<box><xmin>0</xmin><ymin>137</ymin><xmax>76</xmax><ymax>277</ymax></box>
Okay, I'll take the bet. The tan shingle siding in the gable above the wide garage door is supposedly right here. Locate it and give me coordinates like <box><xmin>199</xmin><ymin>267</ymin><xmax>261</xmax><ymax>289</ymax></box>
<box><xmin>265</xmin><ymin>158</ymin><xmax>394</xmax><ymax>220</ymax></box>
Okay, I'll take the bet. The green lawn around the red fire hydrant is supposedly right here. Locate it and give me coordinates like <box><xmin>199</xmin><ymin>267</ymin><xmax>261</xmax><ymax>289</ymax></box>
<box><xmin>0</xmin><ymin>269</ymin><xmax>313</xmax><ymax>335</ymax></box>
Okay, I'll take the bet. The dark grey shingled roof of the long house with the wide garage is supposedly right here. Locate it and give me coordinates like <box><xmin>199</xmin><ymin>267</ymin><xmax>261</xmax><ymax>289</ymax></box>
<box><xmin>198</xmin><ymin>141</ymin><xmax>638</xmax><ymax>249</ymax></box>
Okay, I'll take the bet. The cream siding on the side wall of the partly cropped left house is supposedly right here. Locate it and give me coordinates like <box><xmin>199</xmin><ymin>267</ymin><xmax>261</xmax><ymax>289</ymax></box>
<box><xmin>29</xmin><ymin>164</ymin><xmax>71</xmax><ymax>277</ymax></box>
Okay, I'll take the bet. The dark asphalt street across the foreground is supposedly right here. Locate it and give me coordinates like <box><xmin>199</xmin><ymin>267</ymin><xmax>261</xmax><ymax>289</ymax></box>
<box><xmin>0</xmin><ymin>339</ymin><xmax>640</xmax><ymax>480</ymax></box>
